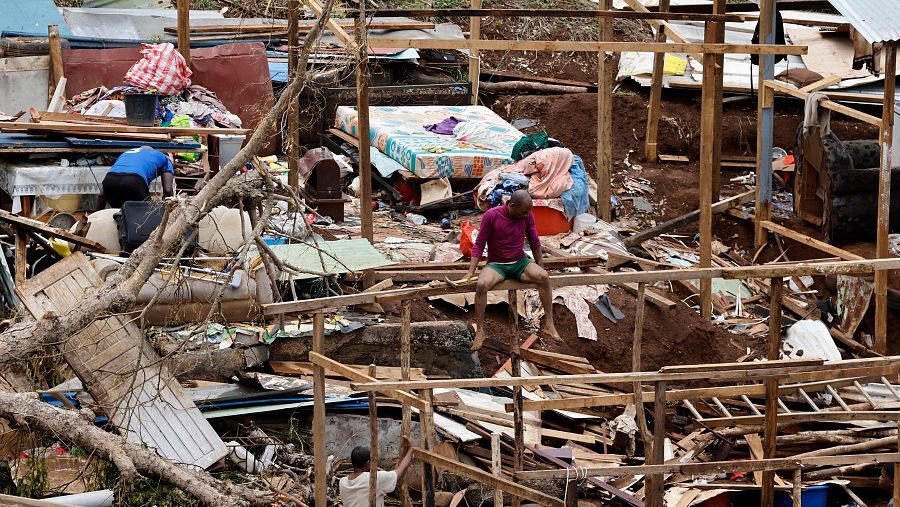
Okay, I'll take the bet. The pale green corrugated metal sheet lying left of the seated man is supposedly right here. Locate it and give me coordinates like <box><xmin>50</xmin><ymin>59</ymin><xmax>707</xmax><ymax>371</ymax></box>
<box><xmin>272</xmin><ymin>238</ymin><xmax>393</xmax><ymax>280</ymax></box>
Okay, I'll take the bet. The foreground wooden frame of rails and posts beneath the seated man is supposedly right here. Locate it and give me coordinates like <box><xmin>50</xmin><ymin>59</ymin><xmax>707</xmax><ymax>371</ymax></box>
<box><xmin>265</xmin><ymin>259</ymin><xmax>900</xmax><ymax>507</ymax></box>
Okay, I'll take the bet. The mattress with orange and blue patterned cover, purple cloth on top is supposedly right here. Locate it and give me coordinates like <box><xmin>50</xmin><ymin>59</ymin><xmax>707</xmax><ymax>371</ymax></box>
<box><xmin>335</xmin><ymin>106</ymin><xmax>523</xmax><ymax>178</ymax></box>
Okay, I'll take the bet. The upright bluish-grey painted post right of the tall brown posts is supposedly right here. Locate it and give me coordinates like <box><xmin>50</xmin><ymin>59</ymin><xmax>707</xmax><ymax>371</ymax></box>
<box><xmin>755</xmin><ymin>0</ymin><xmax>775</xmax><ymax>248</ymax></box>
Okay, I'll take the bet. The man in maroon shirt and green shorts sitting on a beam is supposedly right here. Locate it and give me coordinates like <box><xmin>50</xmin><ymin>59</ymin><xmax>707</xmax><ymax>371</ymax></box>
<box><xmin>467</xmin><ymin>190</ymin><xmax>559</xmax><ymax>350</ymax></box>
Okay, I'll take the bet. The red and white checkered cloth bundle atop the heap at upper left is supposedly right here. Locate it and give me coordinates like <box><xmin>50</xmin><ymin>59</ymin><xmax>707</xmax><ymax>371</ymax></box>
<box><xmin>125</xmin><ymin>42</ymin><xmax>192</xmax><ymax>95</ymax></box>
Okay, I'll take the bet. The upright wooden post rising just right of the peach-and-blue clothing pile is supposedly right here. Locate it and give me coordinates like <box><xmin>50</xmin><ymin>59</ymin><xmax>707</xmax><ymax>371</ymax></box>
<box><xmin>597</xmin><ymin>0</ymin><xmax>613</xmax><ymax>222</ymax></box>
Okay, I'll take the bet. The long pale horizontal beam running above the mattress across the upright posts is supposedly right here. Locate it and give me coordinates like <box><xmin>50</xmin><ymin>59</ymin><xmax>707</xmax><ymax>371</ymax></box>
<box><xmin>369</xmin><ymin>38</ymin><xmax>808</xmax><ymax>55</ymax></box>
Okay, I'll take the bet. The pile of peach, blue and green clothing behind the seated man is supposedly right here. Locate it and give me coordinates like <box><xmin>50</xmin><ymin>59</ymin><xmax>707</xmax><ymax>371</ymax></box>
<box><xmin>475</xmin><ymin>132</ymin><xmax>590</xmax><ymax>220</ymax></box>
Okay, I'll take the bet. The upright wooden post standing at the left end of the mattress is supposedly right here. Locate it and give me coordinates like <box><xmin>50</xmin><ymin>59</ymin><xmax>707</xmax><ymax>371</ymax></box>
<box><xmin>356</xmin><ymin>8</ymin><xmax>375</xmax><ymax>287</ymax></box>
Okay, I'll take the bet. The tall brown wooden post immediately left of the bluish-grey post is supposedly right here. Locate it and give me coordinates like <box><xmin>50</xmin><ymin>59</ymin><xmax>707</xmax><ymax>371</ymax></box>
<box><xmin>700</xmin><ymin>0</ymin><xmax>725</xmax><ymax>319</ymax></box>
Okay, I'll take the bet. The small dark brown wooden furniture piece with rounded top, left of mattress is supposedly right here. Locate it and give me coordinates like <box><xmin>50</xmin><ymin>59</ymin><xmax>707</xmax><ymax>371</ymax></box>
<box><xmin>299</xmin><ymin>148</ymin><xmax>346</xmax><ymax>222</ymax></box>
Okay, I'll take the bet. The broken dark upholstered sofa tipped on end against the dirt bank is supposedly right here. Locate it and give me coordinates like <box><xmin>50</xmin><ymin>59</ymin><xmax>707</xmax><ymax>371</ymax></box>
<box><xmin>794</xmin><ymin>126</ymin><xmax>900</xmax><ymax>243</ymax></box>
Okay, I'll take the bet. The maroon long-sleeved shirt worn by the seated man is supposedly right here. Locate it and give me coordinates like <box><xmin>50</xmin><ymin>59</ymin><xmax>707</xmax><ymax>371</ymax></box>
<box><xmin>472</xmin><ymin>205</ymin><xmax>541</xmax><ymax>262</ymax></box>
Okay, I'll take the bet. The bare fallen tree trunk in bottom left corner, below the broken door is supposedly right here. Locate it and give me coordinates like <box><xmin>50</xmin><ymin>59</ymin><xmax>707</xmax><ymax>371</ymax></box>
<box><xmin>0</xmin><ymin>390</ymin><xmax>272</xmax><ymax>506</ymax></box>
